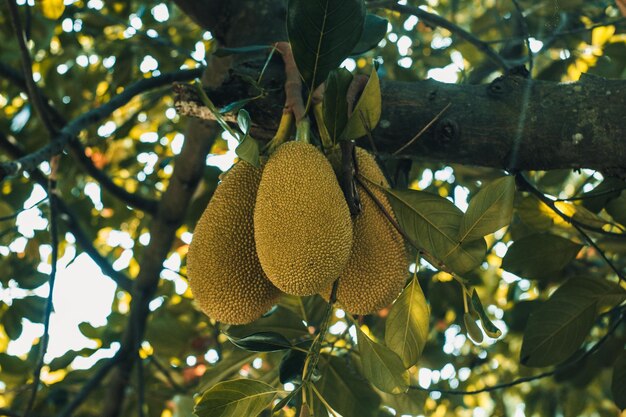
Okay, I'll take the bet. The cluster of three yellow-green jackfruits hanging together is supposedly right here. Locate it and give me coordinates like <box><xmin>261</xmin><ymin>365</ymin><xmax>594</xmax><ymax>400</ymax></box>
<box><xmin>187</xmin><ymin>142</ymin><xmax>408</xmax><ymax>324</ymax></box>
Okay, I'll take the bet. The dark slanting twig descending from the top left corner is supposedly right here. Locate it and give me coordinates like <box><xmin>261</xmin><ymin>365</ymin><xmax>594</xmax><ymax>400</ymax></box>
<box><xmin>7</xmin><ymin>0</ymin><xmax>55</xmax><ymax>132</ymax></box>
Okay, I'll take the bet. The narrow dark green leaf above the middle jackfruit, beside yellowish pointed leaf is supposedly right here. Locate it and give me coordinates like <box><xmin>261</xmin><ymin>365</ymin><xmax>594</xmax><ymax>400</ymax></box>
<box><xmin>322</xmin><ymin>68</ymin><xmax>352</xmax><ymax>143</ymax></box>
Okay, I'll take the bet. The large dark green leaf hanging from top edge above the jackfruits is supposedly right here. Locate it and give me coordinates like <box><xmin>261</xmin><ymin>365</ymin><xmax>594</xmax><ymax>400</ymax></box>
<box><xmin>287</xmin><ymin>0</ymin><xmax>365</xmax><ymax>93</ymax></box>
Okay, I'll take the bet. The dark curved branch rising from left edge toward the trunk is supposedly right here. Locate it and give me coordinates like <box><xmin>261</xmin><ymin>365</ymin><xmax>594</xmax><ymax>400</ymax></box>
<box><xmin>0</xmin><ymin>68</ymin><xmax>204</xmax><ymax>181</ymax></box>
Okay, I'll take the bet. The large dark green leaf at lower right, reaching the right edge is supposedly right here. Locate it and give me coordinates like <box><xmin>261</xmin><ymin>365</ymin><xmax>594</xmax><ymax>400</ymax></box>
<box><xmin>520</xmin><ymin>277</ymin><xmax>626</xmax><ymax>367</ymax></box>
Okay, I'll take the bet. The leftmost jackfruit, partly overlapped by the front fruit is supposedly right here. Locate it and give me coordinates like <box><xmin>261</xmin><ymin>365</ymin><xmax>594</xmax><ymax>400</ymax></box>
<box><xmin>187</xmin><ymin>161</ymin><xmax>280</xmax><ymax>324</ymax></box>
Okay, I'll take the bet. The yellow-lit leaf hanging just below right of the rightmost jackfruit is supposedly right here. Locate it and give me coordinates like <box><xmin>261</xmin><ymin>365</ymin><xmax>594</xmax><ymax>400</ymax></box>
<box><xmin>385</xmin><ymin>278</ymin><xmax>430</xmax><ymax>368</ymax></box>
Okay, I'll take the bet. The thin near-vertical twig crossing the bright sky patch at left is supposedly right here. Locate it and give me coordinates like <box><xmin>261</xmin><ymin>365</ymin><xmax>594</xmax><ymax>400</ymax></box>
<box><xmin>24</xmin><ymin>157</ymin><xmax>59</xmax><ymax>417</ymax></box>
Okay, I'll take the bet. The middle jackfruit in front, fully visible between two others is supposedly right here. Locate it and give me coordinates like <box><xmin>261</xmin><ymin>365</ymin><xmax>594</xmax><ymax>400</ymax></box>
<box><xmin>254</xmin><ymin>142</ymin><xmax>352</xmax><ymax>295</ymax></box>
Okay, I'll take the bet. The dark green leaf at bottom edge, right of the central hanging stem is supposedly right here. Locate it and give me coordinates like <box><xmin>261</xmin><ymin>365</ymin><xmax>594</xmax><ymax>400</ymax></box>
<box><xmin>315</xmin><ymin>355</ymin><xmax>380</xmax><ymax>417</ymax></box>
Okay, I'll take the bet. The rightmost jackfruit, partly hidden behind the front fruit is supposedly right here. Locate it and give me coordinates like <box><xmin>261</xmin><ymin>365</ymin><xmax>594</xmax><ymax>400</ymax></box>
<box><xmin>322</xmin><ymin>147</ymin><xmax>409</xmax><ymax>314</ymax></box>
